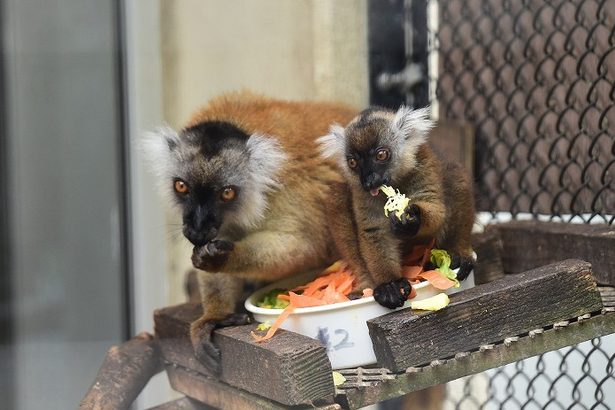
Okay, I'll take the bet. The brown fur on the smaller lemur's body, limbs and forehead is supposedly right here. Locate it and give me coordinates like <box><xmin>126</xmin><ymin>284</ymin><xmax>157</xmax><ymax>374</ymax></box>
<box><xmin>328</xmin><ymin>111</ymin><xmax>475</xmax><ymax>290</ymax></box>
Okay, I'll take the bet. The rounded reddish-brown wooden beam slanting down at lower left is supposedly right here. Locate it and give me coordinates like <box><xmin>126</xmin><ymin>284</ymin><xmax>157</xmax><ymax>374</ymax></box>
<box><xmin>79</xmin><ymin>332</ymin><xmax>162</xmax><ymax>410</ymax></box>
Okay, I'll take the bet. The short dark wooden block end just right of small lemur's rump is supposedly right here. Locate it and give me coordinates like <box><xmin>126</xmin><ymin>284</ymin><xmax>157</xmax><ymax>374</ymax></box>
<box><xmin>472</xmin><ymin>229</ymin><xmax>504</xmax><ymax>285</ymax></box>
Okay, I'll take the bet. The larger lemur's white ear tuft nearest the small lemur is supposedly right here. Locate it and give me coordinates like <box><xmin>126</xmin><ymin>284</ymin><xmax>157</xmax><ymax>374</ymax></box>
<box><xmin>246</xmin><ymin>133</ymin><xmax>287</xmax><ymax>190</ymax></box>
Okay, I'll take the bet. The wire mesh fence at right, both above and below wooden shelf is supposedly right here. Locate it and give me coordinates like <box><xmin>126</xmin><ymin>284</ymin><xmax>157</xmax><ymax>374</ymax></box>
<box><xmin>414</xmin><ymin>0</ymin><xmax>615</xmax><ymax>409</ymax></box>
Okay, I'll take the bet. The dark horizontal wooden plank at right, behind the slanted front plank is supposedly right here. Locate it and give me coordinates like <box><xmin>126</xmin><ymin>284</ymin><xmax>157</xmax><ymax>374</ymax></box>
<box><xmin>496</xmin><ymin>221</ymin><xmax>615</xmax><ymax>286</ymax></box>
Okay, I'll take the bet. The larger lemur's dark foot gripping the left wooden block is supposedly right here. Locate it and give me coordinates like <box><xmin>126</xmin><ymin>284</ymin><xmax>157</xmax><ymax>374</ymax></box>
<box><xmin>190</xmin><ymin>313</ymin><xmax>252</xmax><ymax>375</ymax></box>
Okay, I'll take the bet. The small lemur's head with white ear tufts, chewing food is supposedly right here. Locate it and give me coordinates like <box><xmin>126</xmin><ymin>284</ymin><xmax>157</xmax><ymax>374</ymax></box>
<box><xmin>318</xmin><ymin>106</ymin><xmax>433</xmax><ymax>195</ymax></box>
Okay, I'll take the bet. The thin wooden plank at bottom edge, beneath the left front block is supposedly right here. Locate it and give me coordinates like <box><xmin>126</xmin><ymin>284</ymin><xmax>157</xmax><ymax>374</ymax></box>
<box><xmin>167</xmin><ymin>366</ymin><xmax>340</xmax><ymax>410</ymax></box>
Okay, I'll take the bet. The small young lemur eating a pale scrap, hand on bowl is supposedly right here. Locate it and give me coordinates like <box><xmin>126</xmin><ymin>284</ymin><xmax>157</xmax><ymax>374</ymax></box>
<box><xmin>319</xmin><ymin>106</ymin><xmax>475</xmax><ymax>308</ymax></box>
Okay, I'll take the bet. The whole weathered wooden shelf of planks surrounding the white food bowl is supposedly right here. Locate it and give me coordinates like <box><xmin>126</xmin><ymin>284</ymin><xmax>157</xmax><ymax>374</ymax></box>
<box><xmin>83</xmin><ymin>222</ymin><xmax>615</xmax><ymax>409</ymax></box>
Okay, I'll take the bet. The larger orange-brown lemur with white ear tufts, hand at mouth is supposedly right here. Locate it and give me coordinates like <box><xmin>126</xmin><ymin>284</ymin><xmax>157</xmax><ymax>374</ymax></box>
<box><xmin>145</xmin><ymin>93</ymin><xmax>357</xmax><ymax>370</ymax></box>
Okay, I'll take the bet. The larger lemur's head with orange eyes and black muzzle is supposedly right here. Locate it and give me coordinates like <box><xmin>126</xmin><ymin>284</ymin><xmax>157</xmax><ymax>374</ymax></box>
<box><xmin>144</xmin><ymin>121</ymin><xmax>286</xmax><ymax>246</ymax></box>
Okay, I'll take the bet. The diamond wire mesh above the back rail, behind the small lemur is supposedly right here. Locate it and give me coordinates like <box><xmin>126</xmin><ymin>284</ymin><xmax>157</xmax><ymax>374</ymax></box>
<box><xmin>432</xmin><ymin>0</ymin><xmax>615</xmax><ymax>223</ymax></box>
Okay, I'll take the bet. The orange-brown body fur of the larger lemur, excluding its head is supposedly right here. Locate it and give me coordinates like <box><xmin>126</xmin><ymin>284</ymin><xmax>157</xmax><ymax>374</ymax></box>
<box><xmin>186</xmin><ymin>92</ymin><xmax>357</xmax><ymax>344</ymax></box>
